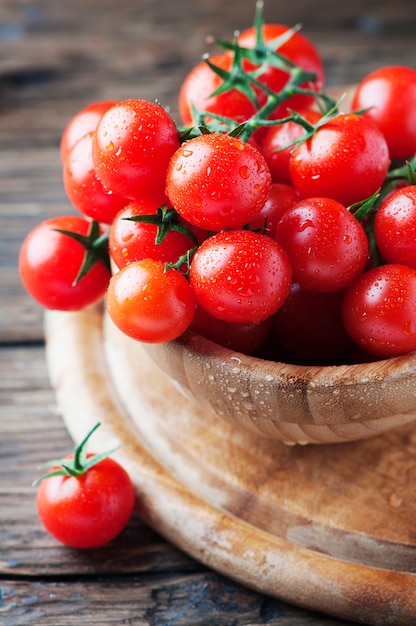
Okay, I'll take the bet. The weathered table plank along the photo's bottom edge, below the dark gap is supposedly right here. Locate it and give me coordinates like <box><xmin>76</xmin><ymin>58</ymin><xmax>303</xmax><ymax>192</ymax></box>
<box><xmin>0</xmin><ymin>572</ymin><xmax>350</xmax><ymax>626</ymax></box>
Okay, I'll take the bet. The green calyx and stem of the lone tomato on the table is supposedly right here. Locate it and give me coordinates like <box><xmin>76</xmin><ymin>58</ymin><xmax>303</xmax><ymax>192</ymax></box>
<box><xmin>33</xmin><ymin>422</ymin><xmax>118</xmax><ymax>486</ymax></box>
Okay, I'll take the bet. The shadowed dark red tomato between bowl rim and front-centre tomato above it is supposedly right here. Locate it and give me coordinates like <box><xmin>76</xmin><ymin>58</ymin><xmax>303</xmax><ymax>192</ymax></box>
<box><xmin>191</xmin><ymin>306</ymin><xmax>272</xmax><ymax>354</ymax></box>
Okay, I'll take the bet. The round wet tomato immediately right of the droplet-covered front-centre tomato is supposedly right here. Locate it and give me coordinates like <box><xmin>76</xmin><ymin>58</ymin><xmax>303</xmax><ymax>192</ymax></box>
<box><xmin>276</xmin><ymin>198</ymin><xmax>369</xmax><ymax>292</ymax></box>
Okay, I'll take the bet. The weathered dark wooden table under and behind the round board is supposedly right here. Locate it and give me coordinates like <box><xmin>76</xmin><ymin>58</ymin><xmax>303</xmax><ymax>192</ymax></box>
<box><xmin>0</xmin><ymin>0</ymin><xmax>416</xmax><ymax>626</ymax></box>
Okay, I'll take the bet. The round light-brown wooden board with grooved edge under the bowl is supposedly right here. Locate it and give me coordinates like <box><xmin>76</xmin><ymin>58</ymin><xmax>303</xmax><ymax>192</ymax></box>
<box><xmin>45</xmin><ymin>308</ymin><xmax>416</xmax><ymax>626</ymax></box>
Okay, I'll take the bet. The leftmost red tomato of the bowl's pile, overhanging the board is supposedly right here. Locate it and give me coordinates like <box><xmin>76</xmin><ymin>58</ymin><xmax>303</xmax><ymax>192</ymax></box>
<box><xmin>19</xmin><ymin>216</ymin><xmax>110</xmax><ymax>311</ymax></box>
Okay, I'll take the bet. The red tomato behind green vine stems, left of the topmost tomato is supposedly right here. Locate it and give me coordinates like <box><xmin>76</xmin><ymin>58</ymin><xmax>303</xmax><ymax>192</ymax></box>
<box><xmin>179</xmin><ymin>54</ymin><xmax>256</xmax><ymax>125</ymax></box>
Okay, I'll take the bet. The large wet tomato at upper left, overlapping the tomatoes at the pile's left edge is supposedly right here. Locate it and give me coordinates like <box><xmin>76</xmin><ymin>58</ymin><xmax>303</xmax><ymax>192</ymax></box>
<box><xmin>92</xmin><ymin>100</ymin><xmax>179</xmax><ymax>205</ymax></box>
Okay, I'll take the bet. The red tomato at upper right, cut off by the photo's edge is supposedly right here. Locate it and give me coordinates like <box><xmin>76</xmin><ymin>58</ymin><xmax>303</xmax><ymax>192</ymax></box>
<box><xmin>351</xmin><ymin>65</ymin><xmax>416</xmax><ymax>159</ymax></box>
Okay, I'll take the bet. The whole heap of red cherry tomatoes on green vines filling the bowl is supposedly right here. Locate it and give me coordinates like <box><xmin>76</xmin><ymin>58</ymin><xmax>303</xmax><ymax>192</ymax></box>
<box><xmin>20</xmin><ymin>7</ymin><xmax>416</xmax><ymax>363</ymax></box>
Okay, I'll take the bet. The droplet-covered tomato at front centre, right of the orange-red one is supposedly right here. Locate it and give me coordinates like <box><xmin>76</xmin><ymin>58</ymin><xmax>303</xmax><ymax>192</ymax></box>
<box><xmin>189</xmin><ymin>230</ymin><xmax>292</xmax><ymax>324</ymax></box>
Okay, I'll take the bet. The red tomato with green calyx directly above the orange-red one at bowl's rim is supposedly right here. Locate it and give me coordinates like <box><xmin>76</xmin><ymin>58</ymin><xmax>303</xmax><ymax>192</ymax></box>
<box><xmin>109</xmin><ymin>202</ymin><xmax>195</xmax><ymax>268</ymax></box>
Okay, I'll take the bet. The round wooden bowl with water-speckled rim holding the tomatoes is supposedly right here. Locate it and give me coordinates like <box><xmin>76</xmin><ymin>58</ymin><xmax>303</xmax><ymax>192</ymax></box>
<box><xmin>143</xmin><ymin>331</ymin><xmax>416</xmax><ymax>444</ymax></box>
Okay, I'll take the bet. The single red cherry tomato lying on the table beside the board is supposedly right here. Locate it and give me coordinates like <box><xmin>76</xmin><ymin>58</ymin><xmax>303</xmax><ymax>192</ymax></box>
<box><xmin>36</xmin><ymin>424</ymin><xmax>135</xmax><ymax>549</ymax></box>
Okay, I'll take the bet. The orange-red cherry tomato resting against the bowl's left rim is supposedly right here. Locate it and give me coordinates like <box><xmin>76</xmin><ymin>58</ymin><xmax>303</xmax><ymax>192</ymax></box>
<box><xmin>107</xmin><ymin>259</ymin><xmax>196</xmax><ymax>343</ymax></box>
